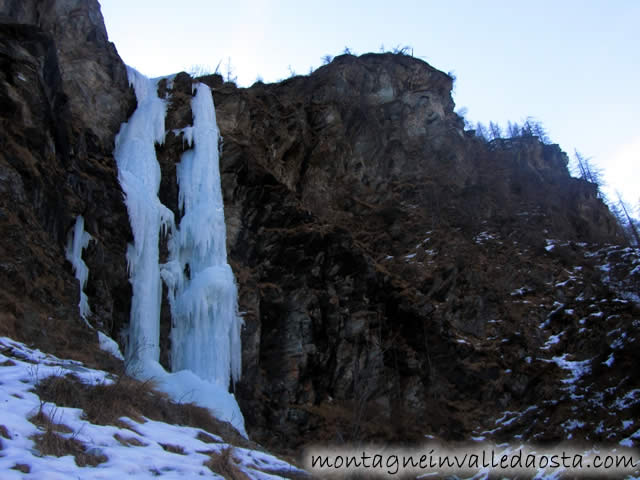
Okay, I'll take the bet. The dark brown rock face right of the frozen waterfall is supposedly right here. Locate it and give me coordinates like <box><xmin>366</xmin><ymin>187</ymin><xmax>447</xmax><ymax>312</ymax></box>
<box><xmin>194</xmin><ymin>55</ymin><xmax>618</xmax><ymax>448</ymax></box>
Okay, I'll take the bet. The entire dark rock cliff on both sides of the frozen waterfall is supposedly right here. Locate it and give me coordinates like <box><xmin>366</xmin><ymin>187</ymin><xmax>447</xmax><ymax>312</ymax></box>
<box><xmin>0</xmin><ymin>0</ymin><xmax>640</xmax><ymax>462</ymax></box>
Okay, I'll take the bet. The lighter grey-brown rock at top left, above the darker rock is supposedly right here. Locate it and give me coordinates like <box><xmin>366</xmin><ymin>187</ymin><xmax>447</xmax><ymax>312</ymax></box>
<box><xmin>0</xmin><ymin>0</ymin><xmax>131</xmax><ymax>148</ymax></box>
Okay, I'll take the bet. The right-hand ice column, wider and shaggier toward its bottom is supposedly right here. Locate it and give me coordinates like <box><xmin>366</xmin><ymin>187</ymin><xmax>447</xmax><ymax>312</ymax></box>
<box><xmin>163</xmin><ymin>84</ymin><xmax>242</xmax><ymax>388</ymax></box>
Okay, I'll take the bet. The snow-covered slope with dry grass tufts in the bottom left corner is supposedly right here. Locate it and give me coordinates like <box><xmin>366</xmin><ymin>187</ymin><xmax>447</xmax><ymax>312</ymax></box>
<box><xmin>0</xmin><ymin>337</ymin><xmax>306</xmax><ymax>480</ymax></box>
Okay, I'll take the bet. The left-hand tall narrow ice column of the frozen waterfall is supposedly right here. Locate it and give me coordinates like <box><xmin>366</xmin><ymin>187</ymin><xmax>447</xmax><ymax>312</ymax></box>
<box><xmin>114</xmin><ymin>67</ymin><xmax>173</xmax><ymax>369</ymax></box>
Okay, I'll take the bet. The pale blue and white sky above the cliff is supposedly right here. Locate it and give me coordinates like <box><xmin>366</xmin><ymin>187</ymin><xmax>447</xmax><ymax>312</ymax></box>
<box><xmin>100</xmin><ymin>0</ymin><xmax>640</xmax><ymax>215</ymax></box>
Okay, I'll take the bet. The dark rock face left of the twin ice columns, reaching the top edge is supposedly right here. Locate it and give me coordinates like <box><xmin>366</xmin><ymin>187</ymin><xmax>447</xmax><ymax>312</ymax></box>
<box><xmin>0</xmin><ymin>1</ymin><xmax>135</xmax><ymax>360</ymax></box>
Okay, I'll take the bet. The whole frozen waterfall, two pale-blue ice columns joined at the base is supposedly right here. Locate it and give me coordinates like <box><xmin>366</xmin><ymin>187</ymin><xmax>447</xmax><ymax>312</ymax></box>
<box><xmin>114</xmin><ymin>68</ymin><xmax>246</xmax><ymax>435</ymax></box>
